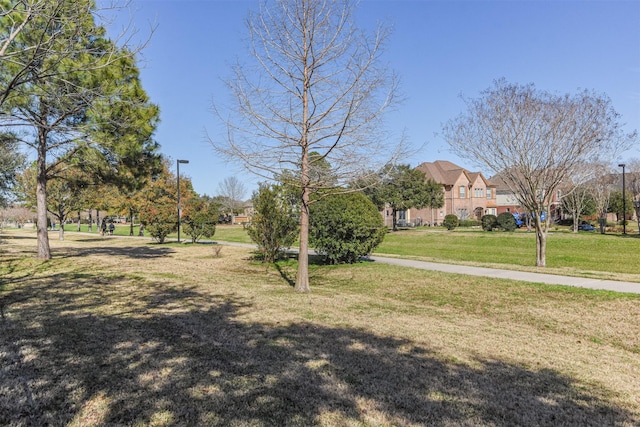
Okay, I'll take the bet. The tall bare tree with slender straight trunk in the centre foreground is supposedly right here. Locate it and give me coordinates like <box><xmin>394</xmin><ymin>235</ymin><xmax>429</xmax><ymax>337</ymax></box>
<box><xmin>212</xmin><ymin>0</ymin><xmax>400</xmax><ymax>292</ymax></box>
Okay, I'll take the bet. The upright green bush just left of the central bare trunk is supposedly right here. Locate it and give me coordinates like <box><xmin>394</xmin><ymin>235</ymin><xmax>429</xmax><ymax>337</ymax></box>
<box><xmin>247</xmin><ymin>183</ymin><xmax>298</xmax><ymax>263</ymax></box>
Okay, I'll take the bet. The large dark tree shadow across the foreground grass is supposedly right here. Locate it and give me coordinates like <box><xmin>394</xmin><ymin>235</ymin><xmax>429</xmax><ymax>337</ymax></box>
<box><xmin>0</xmin><ymin>273</ymin><xmax>640</xmax><ymax>426</ymax></box>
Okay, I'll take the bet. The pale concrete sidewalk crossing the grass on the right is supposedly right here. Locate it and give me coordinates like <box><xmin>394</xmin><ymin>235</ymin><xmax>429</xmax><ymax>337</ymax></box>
<box><xmin>368</xmin><ymin>256</ymin><xmax>640</xmax><ymax>294</ymax></box>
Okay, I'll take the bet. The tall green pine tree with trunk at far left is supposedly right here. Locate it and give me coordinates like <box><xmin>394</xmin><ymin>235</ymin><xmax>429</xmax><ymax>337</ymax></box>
<box><xmin>0</xmin><ymin>0</ymin><xmax>158</xmax><ymax>259</ymax></box>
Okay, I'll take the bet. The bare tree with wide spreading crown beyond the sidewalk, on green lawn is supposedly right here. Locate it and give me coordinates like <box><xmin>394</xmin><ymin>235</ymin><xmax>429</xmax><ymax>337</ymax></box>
<box><xmin>444</xmin><ymin>80</ymin><xmax>637</xmax><ymax>267</ymax></box>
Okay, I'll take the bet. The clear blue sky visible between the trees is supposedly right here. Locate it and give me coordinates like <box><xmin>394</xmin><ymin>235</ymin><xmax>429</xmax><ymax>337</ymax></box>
<box><xmin>102</xmin><ymin>0</ymin><xmax>640</xmax><ymax>198</ymax></box>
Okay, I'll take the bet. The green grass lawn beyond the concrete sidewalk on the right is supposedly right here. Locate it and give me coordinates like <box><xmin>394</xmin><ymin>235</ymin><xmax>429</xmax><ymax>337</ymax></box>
<box><xmin>376</xmin><ymin>228</ymin><xmax>640</xmax><ymax>282</ymax></box>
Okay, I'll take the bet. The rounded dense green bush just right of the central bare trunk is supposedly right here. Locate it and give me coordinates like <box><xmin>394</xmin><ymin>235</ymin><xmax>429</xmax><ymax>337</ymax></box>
<box><xmin>310</xmin><ymin>193</ymin><xmax>387</xmax><ymax>264</ymax></box>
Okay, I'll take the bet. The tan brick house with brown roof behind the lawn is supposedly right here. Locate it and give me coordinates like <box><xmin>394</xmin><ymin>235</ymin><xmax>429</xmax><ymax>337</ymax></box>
<box><xmin>399</xmin><ymin>160</ymin><xmax>498</xmax><ymax>225</ymax></box>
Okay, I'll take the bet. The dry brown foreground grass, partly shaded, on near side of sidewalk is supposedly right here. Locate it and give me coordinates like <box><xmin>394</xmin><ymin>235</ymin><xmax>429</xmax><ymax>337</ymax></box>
<box><xmin>0</xmin><ymin>232</ymin><xmax>640</xmax><ymax>426</ymax></box>
